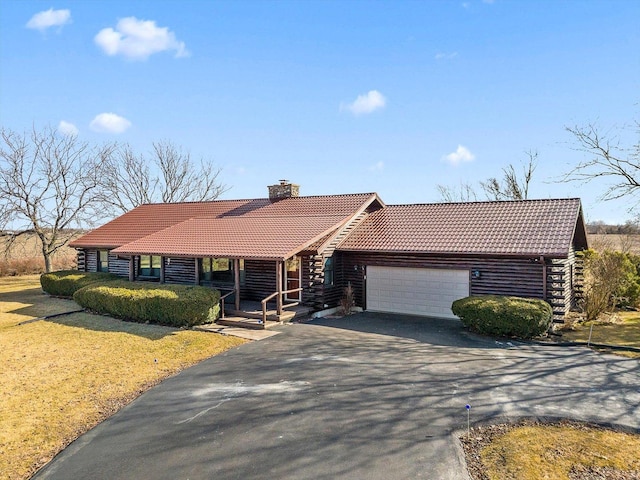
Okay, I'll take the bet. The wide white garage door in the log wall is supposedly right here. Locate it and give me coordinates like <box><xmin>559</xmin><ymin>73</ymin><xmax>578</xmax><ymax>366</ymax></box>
<box><xmin>367</xmin><ymin>266</ymin><xmax>469</xmax><ymax>318</ymax></box>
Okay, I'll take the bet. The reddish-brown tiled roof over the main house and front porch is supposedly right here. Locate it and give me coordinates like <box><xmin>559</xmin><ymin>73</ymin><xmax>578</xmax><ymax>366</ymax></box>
<box><xmin>71</xmin><ymin>193</ymin><xmax>378</xmax><ymax>258</ymax></box>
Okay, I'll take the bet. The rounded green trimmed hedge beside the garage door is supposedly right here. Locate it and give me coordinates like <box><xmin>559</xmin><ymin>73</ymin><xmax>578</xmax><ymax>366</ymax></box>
<box><xmin>451</xmin><ymin>295</ymin><xmax>553</xmax><ymax>338</ymax></box>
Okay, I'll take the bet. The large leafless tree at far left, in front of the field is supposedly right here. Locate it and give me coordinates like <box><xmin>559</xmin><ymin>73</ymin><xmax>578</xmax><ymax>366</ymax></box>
<box><xmin>0</xmin><ymin>127</ymin><xmax>114</xmax><ymax>272</ymax></box>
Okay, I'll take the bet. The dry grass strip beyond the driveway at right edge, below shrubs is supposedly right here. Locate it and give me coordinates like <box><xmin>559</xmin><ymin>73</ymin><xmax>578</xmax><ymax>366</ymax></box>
<box><xmin>561</xmin><ymin>312</ymin><xmax>640</xmax><ymax>358</ymax></box>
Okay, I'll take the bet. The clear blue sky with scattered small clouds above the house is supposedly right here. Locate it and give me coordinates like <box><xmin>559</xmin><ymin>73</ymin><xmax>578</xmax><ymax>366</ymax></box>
<box><xmin>0</xmin><ymin>0</ymin><xmax>640</xmax><ymax>221</ymax></box>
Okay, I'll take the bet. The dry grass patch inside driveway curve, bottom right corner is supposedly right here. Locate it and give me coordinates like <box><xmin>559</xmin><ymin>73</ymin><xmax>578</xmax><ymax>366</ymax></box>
<box><xmin>461</xmin><ymin>422</ymin><xmax>640</xmax><ymax>480</ymax></box>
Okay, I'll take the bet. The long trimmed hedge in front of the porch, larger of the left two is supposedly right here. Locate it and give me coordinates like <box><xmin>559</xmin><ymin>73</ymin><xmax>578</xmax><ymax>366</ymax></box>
<box><xmin>73</xmin><ymin>281</ymin><xmax>220</xmax><ymax>327</ymax></box>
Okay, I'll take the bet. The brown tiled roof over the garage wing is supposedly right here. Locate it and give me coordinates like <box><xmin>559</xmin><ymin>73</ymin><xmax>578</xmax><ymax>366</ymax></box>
<box><xmin>338</xmin><ymin>198</ymin><xmax>586</xmax><ymax>257</ymax></box>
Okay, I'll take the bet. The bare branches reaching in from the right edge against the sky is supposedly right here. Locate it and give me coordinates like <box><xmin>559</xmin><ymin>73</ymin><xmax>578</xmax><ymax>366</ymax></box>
<box><xmin>561</xmin><ymin>121</ymin><xmax>640</xmax><ymax>207</ymax></box>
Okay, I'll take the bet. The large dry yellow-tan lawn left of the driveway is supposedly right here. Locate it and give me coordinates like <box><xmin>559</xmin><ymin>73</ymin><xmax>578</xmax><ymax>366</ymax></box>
<box><xmin>0</xmin><ymin>276</ymin><xmax>244</xmax><ymax>479</ymax></box>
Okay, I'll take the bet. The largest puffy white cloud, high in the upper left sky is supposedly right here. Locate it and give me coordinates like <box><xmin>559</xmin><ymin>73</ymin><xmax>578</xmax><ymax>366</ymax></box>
<box><xmin>94</xmin><ymin>17</ymin><xmax>189</xmax><ymax>60</ymax></box>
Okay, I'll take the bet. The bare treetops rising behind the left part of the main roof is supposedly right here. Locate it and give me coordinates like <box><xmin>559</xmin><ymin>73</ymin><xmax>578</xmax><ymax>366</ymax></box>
<box><xmin>103</xmin><ymin>141</ymin><xmax>228</xmax><ymax>213</ymax></box>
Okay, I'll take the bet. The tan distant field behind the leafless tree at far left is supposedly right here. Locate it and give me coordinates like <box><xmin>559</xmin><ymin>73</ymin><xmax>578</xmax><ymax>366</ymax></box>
<box><xmin>0</xmin><ymin>234</ymin><xmax>76</xmax><ymax>277</ymax></box>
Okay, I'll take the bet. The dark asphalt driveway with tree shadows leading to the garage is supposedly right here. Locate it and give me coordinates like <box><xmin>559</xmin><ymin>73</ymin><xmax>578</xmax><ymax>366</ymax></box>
<box><xmin>35</xmin><ymin>313</ymin><xmax>640</xmax><ymax>480</ymax></box>
